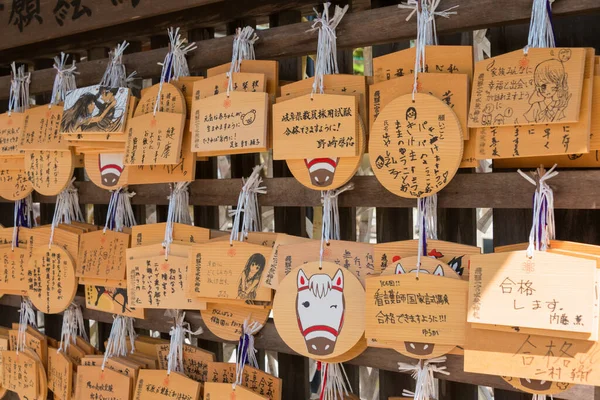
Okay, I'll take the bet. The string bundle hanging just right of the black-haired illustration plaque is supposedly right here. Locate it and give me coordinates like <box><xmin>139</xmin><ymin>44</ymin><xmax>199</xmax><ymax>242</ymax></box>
<box><xmin>154</xmin><ymin>28</ymin><xmax>198</xmax><ymax>115</ymax></box>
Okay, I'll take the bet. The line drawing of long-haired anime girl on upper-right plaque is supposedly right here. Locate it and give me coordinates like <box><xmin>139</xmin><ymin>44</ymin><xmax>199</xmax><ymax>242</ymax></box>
<box><xmin>523</xmin><ymin>59</ymin><xmax>571</xmax><ymax>123</ymax></box>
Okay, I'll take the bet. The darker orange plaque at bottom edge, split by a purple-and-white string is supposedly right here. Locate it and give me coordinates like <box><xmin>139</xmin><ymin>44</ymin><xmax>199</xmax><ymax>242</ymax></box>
<box><xmin>207</xmin><ymin>362</ymin><xmax>282</xmax><ymax>400</ymax></box>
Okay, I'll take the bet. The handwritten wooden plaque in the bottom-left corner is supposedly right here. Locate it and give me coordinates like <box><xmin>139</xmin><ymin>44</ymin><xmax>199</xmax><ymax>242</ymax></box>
<box><xmin>2</xmin><ymin>351</ymin><xmax>41</xmax><ymax>399</ymax></box>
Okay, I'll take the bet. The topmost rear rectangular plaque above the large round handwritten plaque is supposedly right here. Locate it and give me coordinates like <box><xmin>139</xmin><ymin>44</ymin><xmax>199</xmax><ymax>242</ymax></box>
<box><xmin>373</xmin><ymin>46</ymin><xmax>473</xmax><ymax>83</ymax></box>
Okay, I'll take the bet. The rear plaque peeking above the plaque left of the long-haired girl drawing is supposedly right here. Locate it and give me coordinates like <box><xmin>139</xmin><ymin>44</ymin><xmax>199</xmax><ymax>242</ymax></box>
<box><xmin>131</xmin><ymin>222</ymin><xmax>210</xmax><ymax>247</ymax></box>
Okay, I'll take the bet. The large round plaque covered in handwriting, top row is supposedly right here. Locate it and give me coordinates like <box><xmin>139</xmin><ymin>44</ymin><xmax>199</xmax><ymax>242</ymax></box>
<box><xmin>369</xmin><ymin>93</ymin><xmax>463</xmax><ymax>198</ymax></box>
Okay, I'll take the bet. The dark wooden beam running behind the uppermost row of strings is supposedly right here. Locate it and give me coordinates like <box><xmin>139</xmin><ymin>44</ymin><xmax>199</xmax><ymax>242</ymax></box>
<box><xmin>0</xmin><ymin>0</ymin><xmax>600</xmax><ymax>99</ymax></box>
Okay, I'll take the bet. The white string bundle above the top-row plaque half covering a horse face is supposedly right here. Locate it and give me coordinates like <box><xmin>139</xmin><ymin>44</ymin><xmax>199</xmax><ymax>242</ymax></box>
<box><xmin>307</xmin><ymin>2</ymin><xmax>349</xmax><ymax>96</ymax></box>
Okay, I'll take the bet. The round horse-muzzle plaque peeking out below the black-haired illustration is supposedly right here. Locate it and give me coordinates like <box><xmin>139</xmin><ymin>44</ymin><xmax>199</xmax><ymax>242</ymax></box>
<box><xmin>84</xmin><ymin>153</ymin><xmax>129</xmax><ymax>190</ymax></box>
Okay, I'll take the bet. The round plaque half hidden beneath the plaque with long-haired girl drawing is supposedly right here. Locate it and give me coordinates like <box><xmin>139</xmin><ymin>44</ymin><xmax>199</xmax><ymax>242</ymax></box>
<box><xmin>200</xmin><ymin>303</ymin><xmax>271</xmax><ymax>341</ymax></box>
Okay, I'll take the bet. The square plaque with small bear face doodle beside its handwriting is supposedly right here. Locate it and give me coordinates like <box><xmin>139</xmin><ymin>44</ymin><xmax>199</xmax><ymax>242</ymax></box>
<box><xmin>190</xmin><ymin>92</ymin><xmax>269</xmax><ymax>156</ymax></box>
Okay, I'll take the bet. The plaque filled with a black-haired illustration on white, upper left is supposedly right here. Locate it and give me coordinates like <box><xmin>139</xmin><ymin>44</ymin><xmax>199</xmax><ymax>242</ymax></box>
<box><xmin>60</xmin><ymin>85</ymin><xmax>130</xmax><ymax>134</ymax></box>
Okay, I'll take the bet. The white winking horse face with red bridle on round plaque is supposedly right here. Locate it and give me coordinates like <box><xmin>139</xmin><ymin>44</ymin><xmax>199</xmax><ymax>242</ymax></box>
<box><xmin>296</xmin><ymin>268</ymin><xmax>345</xmax><ymax>356</ymax></box>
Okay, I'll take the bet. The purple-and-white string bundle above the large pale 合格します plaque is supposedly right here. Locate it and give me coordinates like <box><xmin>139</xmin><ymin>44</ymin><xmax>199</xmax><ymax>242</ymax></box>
<box><xmin>517</xmin><ymin>164</ymin><xmax>558</xmax><ymax>258</ymax></box>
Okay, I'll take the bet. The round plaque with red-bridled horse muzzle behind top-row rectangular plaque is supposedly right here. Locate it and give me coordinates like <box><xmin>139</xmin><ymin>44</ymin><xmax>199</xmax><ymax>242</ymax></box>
<box><xmin>286</xmin><ymin>116</ymin><xmax>366</xmax><ymax>190</ymax></box>
